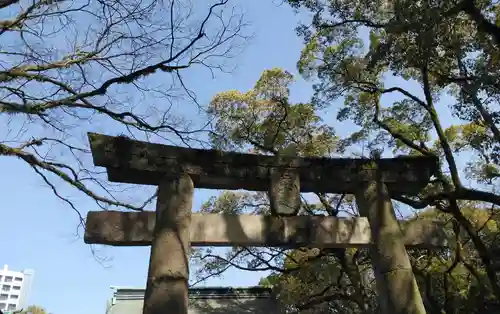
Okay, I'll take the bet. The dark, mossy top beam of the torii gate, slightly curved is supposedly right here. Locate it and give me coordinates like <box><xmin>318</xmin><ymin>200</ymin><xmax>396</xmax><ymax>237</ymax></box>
<box><xmin>88</xmin><ymin>133</ymin><xmax>438</xmax><ymax>194</ymax></box>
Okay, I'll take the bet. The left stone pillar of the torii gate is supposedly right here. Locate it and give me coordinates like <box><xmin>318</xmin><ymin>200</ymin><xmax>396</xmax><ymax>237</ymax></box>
<box><xmin>143</xmin><ymin>174</ymin><xmax>194</xmax><ymax>314</ymax></box>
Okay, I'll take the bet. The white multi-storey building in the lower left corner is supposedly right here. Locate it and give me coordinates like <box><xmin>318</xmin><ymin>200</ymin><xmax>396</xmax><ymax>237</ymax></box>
<box><xmin>0</xmin><ymin>265</ymin><xmax>35</xmax><ymax>311</ymax></box>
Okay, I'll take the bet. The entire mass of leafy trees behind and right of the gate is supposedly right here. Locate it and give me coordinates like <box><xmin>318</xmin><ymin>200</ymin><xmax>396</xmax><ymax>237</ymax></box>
<box><xmin>195</xmin><ymin>0</ymin><xmax>500</xmax><ymax>313</ymax></box>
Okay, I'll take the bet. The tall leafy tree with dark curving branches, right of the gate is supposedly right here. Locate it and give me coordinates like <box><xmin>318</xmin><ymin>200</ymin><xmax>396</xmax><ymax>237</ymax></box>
<box><xmin>280</xmin><ymin>0</ymin><xmax>500</xmax><ymax>312</ymax></box>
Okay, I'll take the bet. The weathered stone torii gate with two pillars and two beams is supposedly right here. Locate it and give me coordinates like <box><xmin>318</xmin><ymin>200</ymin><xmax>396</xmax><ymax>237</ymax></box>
<box><xmin>85</xmin><ymin>133</ymin><xmax>446</xmax><ymax>314</ymax></box>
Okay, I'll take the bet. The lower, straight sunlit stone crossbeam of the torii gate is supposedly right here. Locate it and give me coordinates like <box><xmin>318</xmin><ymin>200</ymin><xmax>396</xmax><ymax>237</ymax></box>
<box><xmin>84</xmin><ymin>211</ymin><xmax>447</xmax><ymax>248</ymax></box>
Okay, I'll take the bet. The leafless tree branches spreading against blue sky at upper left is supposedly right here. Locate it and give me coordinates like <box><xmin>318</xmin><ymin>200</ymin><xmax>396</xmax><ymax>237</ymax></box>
<box><xmin>0</xmin><ymin>0</ymin><xmax>247</xmax><ymax>223</ymax></box>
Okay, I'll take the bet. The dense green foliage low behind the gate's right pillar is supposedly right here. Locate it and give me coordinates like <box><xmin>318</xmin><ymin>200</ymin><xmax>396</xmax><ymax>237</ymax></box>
<box><xmin>260</xmin><ymin>206</ymin><xmax>500</xmax><ymax>313</ymax></box>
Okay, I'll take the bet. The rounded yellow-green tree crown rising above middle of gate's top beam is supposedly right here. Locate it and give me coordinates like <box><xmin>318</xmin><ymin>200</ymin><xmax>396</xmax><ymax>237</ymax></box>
<box><xmin>209</xmin><ymin>69</ymin><xmax>336</xmax><ymax>156</ymax></box>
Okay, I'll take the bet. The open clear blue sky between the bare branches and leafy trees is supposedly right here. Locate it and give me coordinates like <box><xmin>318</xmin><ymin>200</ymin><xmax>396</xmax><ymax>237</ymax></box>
<box><xmin>0</xmin><ymin>0</ymin><xmax>311</xmax><ymax>314</ymax></box>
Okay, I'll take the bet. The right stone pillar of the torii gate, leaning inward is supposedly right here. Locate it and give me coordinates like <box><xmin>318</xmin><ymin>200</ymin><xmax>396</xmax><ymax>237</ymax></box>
<box><xmin>355</xmin><ymin>179</ymin><xmax>425</xmax><ymax>314</ymax></box>
